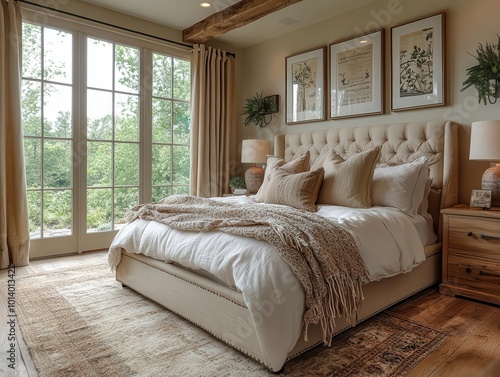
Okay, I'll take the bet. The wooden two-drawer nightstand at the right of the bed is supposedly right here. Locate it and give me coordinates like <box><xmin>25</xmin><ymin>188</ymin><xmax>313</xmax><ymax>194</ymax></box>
<box><xmin>439</xmin><ymin>205</ymin><xmax>500</xmax><ymax>305</ymax></box>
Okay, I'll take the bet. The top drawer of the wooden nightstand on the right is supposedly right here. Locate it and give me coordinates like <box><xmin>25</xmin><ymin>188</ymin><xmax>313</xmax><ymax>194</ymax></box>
<box><xmin>448</xmin><ymin>216</ymin><xmax>500</xmax><ymax>257</ymax></box>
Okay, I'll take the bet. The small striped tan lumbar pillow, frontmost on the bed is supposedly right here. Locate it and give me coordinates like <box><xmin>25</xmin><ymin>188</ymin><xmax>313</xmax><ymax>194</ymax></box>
<box><xmin>264</xmin><ymin>167</ymin><xmax>324</xmax><ymax>212</ymax></box>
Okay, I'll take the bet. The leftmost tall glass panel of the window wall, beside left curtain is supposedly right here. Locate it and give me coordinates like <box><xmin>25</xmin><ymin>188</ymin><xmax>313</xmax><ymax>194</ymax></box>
<box><xmin>21</xmin><ymin>24</ymin><xmax>73</xmax><ymax>238</ymax></box>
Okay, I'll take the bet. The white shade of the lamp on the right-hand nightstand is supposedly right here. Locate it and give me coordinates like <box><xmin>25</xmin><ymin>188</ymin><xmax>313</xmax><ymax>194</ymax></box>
<box><xmin>469</xmin><ymin>120</ymin><xmax>500</xmax><ymax>161</ymax></box>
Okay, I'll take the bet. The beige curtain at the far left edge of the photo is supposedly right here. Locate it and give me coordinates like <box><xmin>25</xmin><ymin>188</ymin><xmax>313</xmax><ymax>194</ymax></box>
<box><xmin>0</xmin><ymin>0</ymin><xmax>29</xmax><ymax>268</ymax></box>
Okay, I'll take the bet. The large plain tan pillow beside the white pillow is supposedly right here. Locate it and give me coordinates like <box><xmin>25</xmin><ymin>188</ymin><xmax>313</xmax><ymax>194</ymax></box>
<box><xmin>318</xmin><ymin>147</ymin><xmax>380</xmax><ymax>208</ymax></box>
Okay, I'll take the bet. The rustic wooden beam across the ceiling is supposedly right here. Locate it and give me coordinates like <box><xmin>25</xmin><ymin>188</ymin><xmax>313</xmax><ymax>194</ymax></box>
<box><xmin>182</xmin><ymin>0</ymin><xmax>302</xmax><ymax>43</ymax></box>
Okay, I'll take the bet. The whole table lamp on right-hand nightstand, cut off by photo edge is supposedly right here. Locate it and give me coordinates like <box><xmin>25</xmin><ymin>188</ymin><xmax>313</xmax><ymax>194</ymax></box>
<box><xmin>469</xmin><ymin>120</ymin><xmax>500</xmax><ymax>207</ymax></box>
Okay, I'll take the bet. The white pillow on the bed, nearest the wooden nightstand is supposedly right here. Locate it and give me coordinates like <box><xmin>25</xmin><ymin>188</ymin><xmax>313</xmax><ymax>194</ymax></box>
<box><xmin>371</xmin><ymin>157</ymin><xmax>429</xmax><ymax>215</ymax></box>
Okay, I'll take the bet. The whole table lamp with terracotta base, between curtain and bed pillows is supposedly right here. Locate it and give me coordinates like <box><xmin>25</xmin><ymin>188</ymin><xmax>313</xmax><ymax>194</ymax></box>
<box><xmin>241</xmin><ymin>139</ymin><xmax>269</xmax><ymax>194</ymax></box>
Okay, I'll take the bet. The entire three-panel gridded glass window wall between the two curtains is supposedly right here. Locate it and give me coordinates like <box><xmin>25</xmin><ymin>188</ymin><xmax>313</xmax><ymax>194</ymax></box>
<box><xmin>22</xmin><ymin>12</ymin><xmax>191</xmax><ymax>256</ymax></box>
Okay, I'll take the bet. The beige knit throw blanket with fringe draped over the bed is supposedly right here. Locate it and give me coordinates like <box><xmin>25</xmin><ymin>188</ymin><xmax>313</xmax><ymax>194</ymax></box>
<box><xmin>126</xmin><ymin>195</ymin><xmax>367</xmax><ymax>345</ymax></box>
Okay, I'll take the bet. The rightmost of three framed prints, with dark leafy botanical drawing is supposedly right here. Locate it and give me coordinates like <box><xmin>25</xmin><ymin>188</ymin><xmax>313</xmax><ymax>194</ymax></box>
<box><xmin>391</xmin><ymin>12</ymin><xmax>446</xmax><ymax>111</ymax></box>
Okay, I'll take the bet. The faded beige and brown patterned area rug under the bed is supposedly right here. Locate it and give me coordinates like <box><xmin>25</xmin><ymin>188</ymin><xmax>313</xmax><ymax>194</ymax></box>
<box><xmin>16</xmin><ymin>265</ymin><xmax>446</xmax><ymax>377</ymax></box>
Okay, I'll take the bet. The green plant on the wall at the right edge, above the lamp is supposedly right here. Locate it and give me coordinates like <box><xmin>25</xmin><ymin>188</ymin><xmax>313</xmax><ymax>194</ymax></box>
<box><xmin>461</xmin><ymin>35</ymin><xmax>500</xmax><ymax>105</ymax></box>
